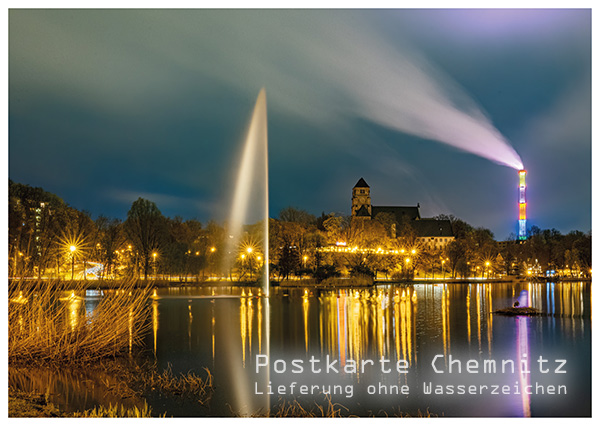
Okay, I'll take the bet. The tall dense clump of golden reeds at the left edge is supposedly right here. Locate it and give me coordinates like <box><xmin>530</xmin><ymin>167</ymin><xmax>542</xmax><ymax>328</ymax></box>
<box><xmin>8</xmin><ymin>281</ymin><xmax>150</xmax><ymax>364</ymax></box>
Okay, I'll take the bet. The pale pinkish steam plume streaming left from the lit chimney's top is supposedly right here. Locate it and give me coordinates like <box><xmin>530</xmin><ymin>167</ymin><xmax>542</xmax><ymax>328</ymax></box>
<box><xmin>278</xmin><ymin>15</ymin><xmax>523</xmax><ymax>170</ymax></box>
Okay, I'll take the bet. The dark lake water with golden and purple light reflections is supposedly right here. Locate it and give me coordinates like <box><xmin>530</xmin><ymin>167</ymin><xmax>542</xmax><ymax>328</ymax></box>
<box><xmin>11</xmin><ymin>282</ymin><xmax>591</xmax><ymax>417</ymax></box>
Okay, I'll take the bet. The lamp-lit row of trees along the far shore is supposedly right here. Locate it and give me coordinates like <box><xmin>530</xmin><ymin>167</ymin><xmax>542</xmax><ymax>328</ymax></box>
<box><xmin>8</xmin><ymin>181</ymin><xmax>591</xmax><ymax>281</ymax></box>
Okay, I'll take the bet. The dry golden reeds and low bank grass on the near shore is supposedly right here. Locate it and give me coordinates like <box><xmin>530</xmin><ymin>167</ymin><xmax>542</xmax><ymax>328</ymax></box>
<box><xmin>8</xmin><ymin>280</ymin><xmax>213</xmax><ymax>417</ymax></box>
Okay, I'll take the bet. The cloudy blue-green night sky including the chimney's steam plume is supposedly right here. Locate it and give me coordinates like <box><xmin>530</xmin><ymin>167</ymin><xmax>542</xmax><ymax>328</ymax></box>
<box><xmin>9</xmin><ymin>10</ymin><xmax>592</xmax><ymax>240</ymax></box>
